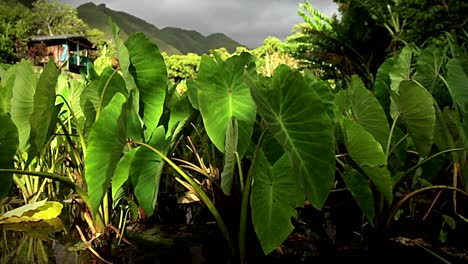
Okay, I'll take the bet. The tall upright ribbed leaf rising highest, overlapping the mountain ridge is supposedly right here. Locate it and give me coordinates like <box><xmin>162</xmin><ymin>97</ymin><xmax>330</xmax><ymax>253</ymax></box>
<box><xmin>125</xmin><ymin>33</ymin><xmax>167</xmax><ymax>139</ymax></box>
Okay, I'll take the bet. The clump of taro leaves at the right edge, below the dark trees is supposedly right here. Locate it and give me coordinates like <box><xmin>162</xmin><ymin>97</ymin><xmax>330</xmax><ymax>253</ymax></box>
<box><xmin>334</xmin><ymin>41</ymin><xmax>467</xmax><ymax>243</ymax></box>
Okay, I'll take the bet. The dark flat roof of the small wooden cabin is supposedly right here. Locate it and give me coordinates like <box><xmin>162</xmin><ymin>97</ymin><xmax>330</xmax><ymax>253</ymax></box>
<box><xmin>28</xmin><ymin>34</ymin><xmax>96</xmax><ymax>50</ymax></box>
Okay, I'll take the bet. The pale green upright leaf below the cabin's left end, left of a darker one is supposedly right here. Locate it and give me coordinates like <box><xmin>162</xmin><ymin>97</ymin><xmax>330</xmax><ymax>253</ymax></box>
<box><xmin>10</xmin><ymin>60</ymin><xmax>37</xmax><ymax>151</ymax></box>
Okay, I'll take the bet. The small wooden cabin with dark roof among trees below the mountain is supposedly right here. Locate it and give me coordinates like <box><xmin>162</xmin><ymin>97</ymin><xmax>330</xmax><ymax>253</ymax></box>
<box><xmin>28</xmin><ymin>35</ymin><xmax>97</xmax><ymax>73</ymax></box>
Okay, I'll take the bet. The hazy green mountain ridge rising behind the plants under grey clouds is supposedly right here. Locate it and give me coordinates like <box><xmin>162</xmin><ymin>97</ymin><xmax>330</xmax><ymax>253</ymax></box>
<box><xmin>77</xmin><ymin>2</ymin><xmax>243</xmax><ymax>54</ymax></box>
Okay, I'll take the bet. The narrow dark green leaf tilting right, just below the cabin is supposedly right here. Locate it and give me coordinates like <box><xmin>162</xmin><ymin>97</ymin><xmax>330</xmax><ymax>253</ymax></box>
<box><xmin>28</xmin><ymin>61</ymin><xmax>60</xmax><ymax>159</ymax></box>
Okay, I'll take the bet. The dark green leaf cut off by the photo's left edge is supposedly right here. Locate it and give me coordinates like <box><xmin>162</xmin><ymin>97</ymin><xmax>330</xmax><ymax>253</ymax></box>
<box><xmin>0</xmin><ymin>113</ymin><xmax>19</xmax><ymax>198</ymax></box>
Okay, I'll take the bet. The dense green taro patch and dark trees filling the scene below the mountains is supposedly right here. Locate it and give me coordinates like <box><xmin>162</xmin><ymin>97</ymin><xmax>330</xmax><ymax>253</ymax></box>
<box><xmin>0</xmin><ymin>0</ymin><xmax>468</xmax><ymax>263</ymax></box>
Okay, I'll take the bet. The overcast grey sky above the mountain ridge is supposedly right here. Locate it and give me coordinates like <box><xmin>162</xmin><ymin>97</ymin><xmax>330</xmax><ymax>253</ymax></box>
<box><xmin>61</xmin><ymin>0</ymin><xmax>337</xmax><ymax>48</ymax></box>
